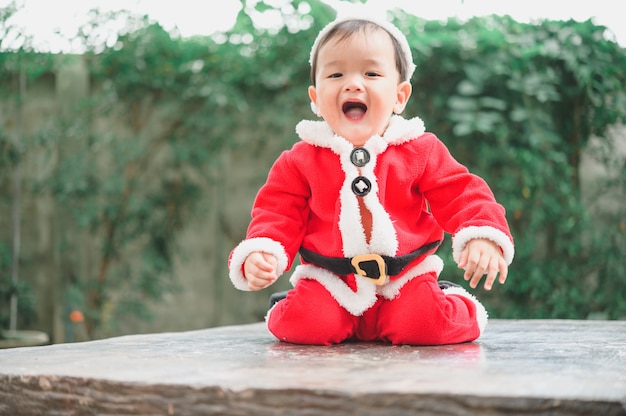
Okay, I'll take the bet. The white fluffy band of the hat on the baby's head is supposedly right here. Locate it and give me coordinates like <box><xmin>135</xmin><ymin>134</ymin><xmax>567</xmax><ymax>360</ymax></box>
<box><xmin>309</xmin><ymin>11</ymin><xmax>415</xmax><ymax>114</ymax></box>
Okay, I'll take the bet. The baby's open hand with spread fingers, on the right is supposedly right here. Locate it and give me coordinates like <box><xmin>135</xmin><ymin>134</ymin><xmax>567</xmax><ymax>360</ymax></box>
<box><xmin>459</xmin><ymin>238</ymin><xmax>509</xmax><ymax>290</ymax></box>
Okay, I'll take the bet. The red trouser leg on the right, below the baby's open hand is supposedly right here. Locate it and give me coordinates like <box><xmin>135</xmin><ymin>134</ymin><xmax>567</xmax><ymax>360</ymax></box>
<box><xmin>377</xmin><ymin>273</ymin><xmax>480</xmax><ymax>345</ymax></box>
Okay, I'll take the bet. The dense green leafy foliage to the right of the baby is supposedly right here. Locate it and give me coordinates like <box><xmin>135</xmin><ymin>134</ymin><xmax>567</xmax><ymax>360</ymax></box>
<box><xmin>401</xmin><ymin>16</ymin><xmax>626</xmax><ymax>318</ymax></box>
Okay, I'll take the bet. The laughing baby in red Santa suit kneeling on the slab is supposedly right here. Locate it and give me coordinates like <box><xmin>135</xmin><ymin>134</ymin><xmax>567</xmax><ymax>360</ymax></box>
<box><xmin>229</xmin><ymin>13</ymin><xmax>514</xmax><ymax>345</ymax></box>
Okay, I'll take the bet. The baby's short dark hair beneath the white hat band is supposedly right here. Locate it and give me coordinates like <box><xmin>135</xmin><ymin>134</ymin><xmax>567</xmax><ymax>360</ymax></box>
<box><xmin>311</xmin><ymin>19</ymin><xmax>410</xmax><ymax>86</ymax></box>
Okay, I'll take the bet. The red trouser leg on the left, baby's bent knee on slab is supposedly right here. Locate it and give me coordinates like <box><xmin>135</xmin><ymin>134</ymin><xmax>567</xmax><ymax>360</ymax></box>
<box><xmin>267</xmin><ymin>279</ymin><xmax>358</xmax><ymax>345</ymax></box>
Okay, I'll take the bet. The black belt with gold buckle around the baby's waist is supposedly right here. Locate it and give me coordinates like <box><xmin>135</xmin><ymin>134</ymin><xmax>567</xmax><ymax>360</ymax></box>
<box><xmin>300</xmin><ymin>241</ymin><xmax>441</xmax><ymax>285</ymax></box>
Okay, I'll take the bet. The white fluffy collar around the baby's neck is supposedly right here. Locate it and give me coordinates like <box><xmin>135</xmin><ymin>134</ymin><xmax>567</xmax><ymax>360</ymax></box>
<box><xmin>296</xmin><ymin>115</ymin><xmax>425</xmax><ymax>154</ymax></box>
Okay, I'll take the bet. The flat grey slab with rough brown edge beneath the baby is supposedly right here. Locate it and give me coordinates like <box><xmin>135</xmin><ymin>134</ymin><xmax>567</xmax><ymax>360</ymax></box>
<box><xmin>0</xmin><ymin>320</ymin><xmax>626</xmax><ymax>416</ymax></box>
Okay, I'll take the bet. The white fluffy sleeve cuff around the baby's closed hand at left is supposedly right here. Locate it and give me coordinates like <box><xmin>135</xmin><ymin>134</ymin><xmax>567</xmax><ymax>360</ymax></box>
<box><xmin>228</xmin><ymin>237</ymin><xmax>288</xmax><ymax>291</ymax></box>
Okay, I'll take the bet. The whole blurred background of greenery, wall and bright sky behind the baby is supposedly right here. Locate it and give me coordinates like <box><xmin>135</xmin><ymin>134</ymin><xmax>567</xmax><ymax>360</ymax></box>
<box><xmin>0</xmin><ymin>0</ymin><xmax>626</xmax><ymax>343</ymax></box>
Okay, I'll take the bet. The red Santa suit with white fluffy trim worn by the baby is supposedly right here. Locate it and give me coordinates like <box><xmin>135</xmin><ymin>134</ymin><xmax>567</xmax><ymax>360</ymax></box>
<box><xmin>229</xmin><ymin>115</ymin><xmax>514</xmax><ymax>345</ymax></box>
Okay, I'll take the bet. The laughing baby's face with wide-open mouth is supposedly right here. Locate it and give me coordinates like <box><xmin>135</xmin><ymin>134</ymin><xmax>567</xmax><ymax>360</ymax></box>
<box><xmin>309</xmin><ymin>29</ymin><xmax>411</xmax><ymax>146</ymax></box>
